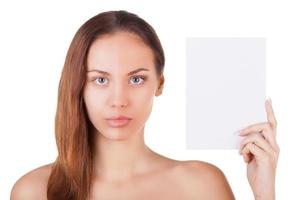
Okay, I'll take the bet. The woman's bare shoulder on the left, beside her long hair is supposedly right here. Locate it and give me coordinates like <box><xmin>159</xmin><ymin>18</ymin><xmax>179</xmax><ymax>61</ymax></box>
<box><xmin>10</xmin><ymin>163</ymin><xmax>52</xmax><ymax>200</ymax></box>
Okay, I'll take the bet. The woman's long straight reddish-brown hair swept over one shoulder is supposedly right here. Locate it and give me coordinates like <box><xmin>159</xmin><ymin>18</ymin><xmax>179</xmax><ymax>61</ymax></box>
<box><xmin>47</xmin><ymin>10</ymin><xmax>165</xmax><ymax>200</ymax></box>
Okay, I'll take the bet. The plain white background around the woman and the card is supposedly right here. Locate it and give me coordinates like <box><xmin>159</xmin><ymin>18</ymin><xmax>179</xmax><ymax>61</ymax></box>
<box><xmin>0</xmin><ymin>0</ymin><xmax>300</xmax><ymax>200</ymax></box>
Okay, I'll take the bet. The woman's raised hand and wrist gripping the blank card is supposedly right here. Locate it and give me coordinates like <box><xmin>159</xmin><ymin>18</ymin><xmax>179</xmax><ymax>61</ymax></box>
<box><xmin>240</xmin><ymin>100</ymin><xmax>279</xmax><ymax>200</ymax></box>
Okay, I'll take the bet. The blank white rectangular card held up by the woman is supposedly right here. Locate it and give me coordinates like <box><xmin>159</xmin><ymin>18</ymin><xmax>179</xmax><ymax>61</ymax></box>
<box><xmin>186</xmin><ymin>38</ymin><xmax>266</xmax><ymax>149</ymax></box>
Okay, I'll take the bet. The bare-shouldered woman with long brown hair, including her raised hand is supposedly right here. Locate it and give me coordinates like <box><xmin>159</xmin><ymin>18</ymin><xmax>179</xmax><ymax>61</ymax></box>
<box><xmin>11</xmin><ymin>11</ymin><xmax>279</xmax><ymax>200</ymax></box>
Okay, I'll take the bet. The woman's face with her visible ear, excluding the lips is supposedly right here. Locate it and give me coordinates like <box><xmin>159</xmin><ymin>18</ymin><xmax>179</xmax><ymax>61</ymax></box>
<box><xmin>83</xmin><ymin>32</ymin><xmax>164</xmax><ymax>140</ymax></box>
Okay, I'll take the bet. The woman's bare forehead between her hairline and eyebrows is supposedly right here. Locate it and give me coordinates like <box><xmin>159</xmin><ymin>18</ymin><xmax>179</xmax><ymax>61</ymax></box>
<box><xmin>87</xmin><ymin>33</ymin><xmax>154</xmax><ymax>71</ymax></box>
